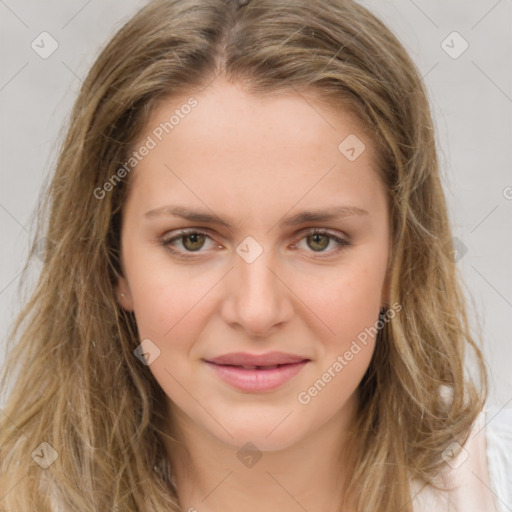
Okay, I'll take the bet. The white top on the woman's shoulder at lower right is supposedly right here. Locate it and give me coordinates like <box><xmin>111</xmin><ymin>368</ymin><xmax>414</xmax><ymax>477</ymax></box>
<box><xmin>412</xmin><ymin>408</ymin><xmax>512</xmax><ymax>512</ymax></box>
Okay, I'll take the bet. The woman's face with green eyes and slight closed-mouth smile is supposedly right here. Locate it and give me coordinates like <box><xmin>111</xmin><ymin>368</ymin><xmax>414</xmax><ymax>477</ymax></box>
<box><xmin>118</xmin><ymin>79</ymin><xmax>390</xmax><ymax>450</ymax></box>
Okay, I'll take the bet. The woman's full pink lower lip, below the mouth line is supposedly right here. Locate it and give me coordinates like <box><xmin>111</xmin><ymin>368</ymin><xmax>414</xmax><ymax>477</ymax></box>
<box><xmin>206</xmin><ymin>361</ymin><xmax>308</xmax><ymax>392</ymax></box>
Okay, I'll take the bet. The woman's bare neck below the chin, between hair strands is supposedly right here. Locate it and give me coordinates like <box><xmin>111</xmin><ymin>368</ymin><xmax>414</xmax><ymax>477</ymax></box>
<box><xmin>166</xmin><ymin>396</ymin><xmax>354</xmax><ymax>512</ymax></box>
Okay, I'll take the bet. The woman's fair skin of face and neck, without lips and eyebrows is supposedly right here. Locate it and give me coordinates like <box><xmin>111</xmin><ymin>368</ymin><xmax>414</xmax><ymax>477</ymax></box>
<box><xmin>118</xmin><ymin>79</ymin><xmax>390</xmax><ymax>512</ymax></box>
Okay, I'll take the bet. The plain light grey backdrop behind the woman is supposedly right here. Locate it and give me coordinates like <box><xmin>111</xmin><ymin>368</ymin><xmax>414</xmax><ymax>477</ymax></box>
<box><xmin>0</xmin><ymin>0</ymin><xmax>512</xmax><ymax>407</ymax></box>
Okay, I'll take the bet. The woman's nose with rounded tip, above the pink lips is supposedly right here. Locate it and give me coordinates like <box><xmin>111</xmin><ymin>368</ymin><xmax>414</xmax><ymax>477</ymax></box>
<box><xmin>221</xmin><ymin>246</ymin><xmax>293</xmax><ymax>337</ymax></box>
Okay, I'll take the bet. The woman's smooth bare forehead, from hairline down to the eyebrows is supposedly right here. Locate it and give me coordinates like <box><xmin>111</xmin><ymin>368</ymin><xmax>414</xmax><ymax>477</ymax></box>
<box><xmin>126</xmin><ymin>79</ymin><xmax>383</xmax><ymax>219</ymax></box>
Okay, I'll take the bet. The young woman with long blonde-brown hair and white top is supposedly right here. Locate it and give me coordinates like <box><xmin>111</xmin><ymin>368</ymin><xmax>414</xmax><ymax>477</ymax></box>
<box><xmin>0</xmin><ymin>0</ymin><xmax>509</xmax><ymax>512</ymax></box>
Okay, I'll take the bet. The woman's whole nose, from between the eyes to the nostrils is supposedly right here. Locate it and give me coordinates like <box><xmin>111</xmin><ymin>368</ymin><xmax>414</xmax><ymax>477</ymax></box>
<box><xmin>224</xmin><ymin>240</ymin><xmax>291</xmax><ymax>335</ymax></box>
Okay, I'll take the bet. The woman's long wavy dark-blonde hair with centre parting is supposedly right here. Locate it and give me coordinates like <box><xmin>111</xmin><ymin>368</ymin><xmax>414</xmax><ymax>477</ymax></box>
<box><xmin>0</xmin><ymin>0</ymin><xmax>487</xmax><ymax>512</ymax></box>
